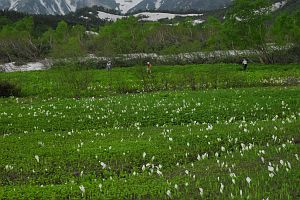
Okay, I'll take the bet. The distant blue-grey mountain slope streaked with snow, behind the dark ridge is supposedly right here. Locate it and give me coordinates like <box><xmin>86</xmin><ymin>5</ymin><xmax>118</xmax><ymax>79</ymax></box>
<box><xmin>0</xmin><ymin>0</ymin><xmax>232</xmax><ymax>15</ymax></box>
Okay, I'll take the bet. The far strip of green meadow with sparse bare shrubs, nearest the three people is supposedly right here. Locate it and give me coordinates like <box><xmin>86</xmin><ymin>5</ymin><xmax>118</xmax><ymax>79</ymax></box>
<box><xmin>0</xmin><ymin>64</ymin><xmax>300</xmax><ymax>98</ymax></box>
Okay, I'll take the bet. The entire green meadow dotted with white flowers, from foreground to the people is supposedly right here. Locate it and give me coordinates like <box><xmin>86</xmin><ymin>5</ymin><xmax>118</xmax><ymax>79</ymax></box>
<box><xmin>0</xmin><ymin>65</ymin><xmax>300</xmax><ymax>199</ymax></box>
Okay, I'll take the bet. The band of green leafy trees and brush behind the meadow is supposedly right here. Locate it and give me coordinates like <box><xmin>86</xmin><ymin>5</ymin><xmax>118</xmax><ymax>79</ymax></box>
<box><xmin>0</xmin><ymin>0</ymin><xmax>300</xmax><ymax>63</ymax></box>
